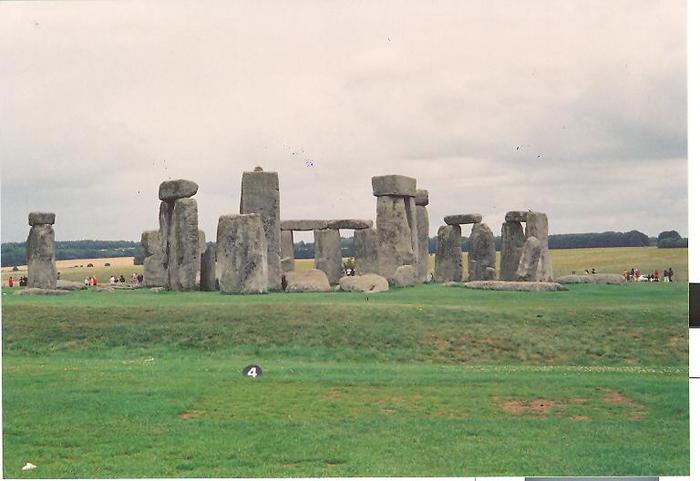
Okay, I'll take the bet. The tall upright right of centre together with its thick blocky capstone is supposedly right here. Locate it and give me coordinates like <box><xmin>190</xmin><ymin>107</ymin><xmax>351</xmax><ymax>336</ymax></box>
<box><xmin>372</xmin><ymin>175</ymin><xmax>418</xmax><ymax>278</ymax></box>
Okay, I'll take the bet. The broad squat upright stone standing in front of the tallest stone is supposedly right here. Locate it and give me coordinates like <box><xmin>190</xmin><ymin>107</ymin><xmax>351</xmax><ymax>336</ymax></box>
<box><xmin>216</xmin><ymin>214</ymin><xmax>268</xmax><ymax>294</ymax></box>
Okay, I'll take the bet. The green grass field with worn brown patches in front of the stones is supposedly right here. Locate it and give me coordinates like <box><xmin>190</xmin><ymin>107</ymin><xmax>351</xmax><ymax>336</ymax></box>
<box><xmin>2</xmin><ymin>278</ymin><xmax>689</xmax><ymax>478</ymax></box>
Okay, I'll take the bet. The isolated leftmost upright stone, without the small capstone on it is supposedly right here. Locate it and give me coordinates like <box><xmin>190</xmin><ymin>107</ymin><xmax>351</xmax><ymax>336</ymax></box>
<box><xmin>27</xmin><ymin>224</ymin><xmax>56</xmax><ymax>289</ymax></box>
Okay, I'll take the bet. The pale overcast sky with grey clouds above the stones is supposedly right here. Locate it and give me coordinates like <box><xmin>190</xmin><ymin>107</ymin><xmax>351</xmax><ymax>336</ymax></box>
<box><xmin>0</xmin><ymin>0</ymin><xmax>688</xmax><ymax>241</ymax></box>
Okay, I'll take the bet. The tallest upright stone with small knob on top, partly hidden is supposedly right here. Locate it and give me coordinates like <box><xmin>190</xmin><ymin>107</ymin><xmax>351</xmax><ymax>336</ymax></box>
<box><xmin>240</xmin><ymin>169</ymin><xmax>282</xmax><ymax>290</ymax></box>
